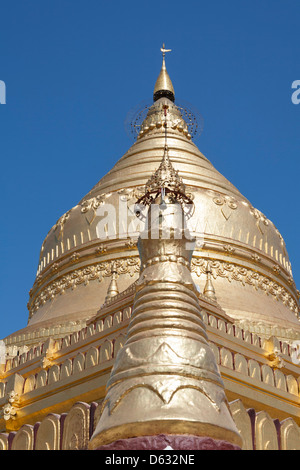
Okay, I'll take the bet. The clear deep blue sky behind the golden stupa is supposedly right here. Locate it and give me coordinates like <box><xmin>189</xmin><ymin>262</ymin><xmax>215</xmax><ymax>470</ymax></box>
<box><xmin>0</xmin><ymin>0</ymin><xmax>300</xmax><ymax>338</ymax></box>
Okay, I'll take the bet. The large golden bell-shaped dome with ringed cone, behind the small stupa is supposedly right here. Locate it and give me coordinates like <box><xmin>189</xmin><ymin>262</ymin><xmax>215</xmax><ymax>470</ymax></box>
<box><xmin>5</xmin><ymin>52</ymin><xmax>300</xmax><ymax>346</ymax></box>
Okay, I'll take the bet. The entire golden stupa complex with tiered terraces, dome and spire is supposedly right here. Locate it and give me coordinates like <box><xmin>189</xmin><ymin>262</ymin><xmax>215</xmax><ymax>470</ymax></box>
<box><xmin>0</xmin><ymin>46</ymin><xmax>300</xmax><ymax>450</ymax></box>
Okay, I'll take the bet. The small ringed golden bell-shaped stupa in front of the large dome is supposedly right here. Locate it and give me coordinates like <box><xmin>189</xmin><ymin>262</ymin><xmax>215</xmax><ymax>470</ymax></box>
<box><xmin>90</xmin><ymin>193</ymin><xmax>241</xmax><ymax>449</ymax></box>
